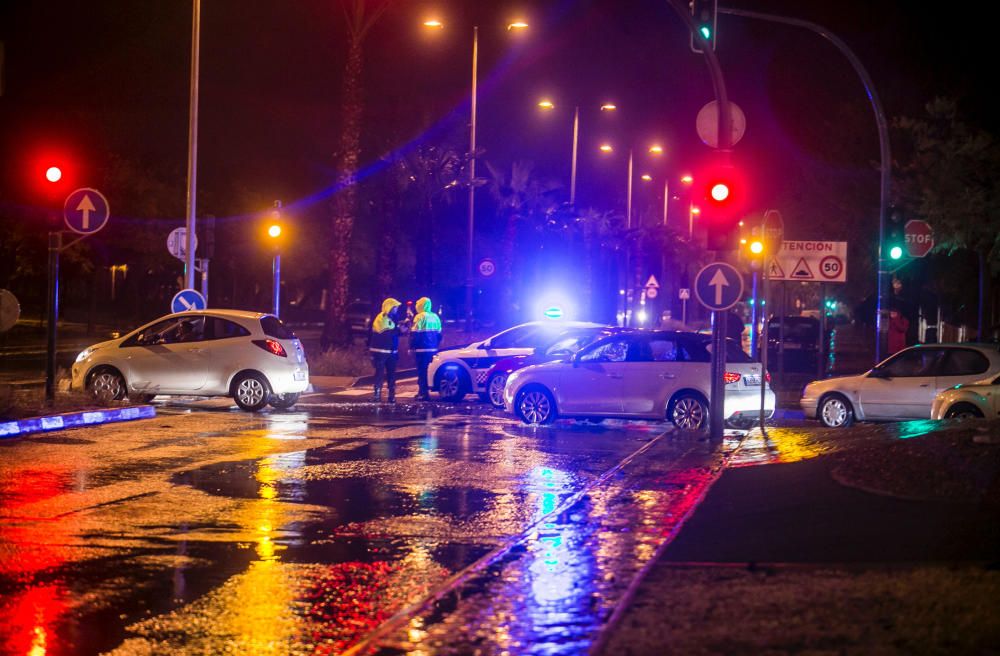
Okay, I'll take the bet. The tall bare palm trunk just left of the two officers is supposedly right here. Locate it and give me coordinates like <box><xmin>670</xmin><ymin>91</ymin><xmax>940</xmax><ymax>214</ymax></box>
<box><xmin>322</xmin><ymin>0</ymin><xmax>389</xmax><ymax>346</ymax></box>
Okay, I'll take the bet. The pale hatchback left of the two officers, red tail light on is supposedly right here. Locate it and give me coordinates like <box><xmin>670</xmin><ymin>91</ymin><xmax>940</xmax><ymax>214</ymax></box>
<box><xmin>72</xmin><ymin>310</ymin><xmax>309</xmax><ymax>412</ymax></box>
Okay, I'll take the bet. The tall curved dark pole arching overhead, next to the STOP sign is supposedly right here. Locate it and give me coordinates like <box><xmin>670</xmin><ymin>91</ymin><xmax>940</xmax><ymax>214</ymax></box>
<box><xmin>718</xmin><ymin>7</ymin><xmax>892</xmax><ymax>364</ymax></box>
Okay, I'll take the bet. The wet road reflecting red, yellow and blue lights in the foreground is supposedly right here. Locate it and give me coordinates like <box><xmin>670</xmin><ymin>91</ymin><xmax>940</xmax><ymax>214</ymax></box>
<box><xmin>0</xmin><ymin>402</ymin><xmax>806</xmax><ymax>654</ymax></box>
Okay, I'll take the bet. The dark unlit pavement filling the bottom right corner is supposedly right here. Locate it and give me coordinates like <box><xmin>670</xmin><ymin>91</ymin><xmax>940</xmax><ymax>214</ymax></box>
<box><xmin>600</xmin><ymin>422</ymin><xmax>1000</xmax><ymax>654</ymax></box>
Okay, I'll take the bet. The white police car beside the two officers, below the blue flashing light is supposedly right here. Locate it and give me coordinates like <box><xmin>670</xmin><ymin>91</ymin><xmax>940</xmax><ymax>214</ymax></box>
<box><xmin>427</xmin><ymin>321</ymin><xmax>601</xmax><ymax>401</ymax></box>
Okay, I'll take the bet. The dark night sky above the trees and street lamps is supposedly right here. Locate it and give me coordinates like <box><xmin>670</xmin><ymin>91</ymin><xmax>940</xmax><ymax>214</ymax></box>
<box><xmin>0</xmin><ymin>0</ymin><xmax>997</xmax><ymax>243</ymax></box>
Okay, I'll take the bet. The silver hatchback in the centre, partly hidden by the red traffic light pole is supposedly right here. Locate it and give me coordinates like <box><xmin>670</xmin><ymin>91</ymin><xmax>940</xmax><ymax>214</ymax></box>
<box><xmin>504</xmin><ymin>330</ymin><xmax>774</xmax><ymax>430</ymax></box>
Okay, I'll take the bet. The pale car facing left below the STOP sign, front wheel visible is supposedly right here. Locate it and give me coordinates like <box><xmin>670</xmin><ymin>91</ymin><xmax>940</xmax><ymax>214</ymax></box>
<box><xmin>801</xmin><ymin>344</ymin><xmax>1000</xmax><ymax>428</ymax></box>
